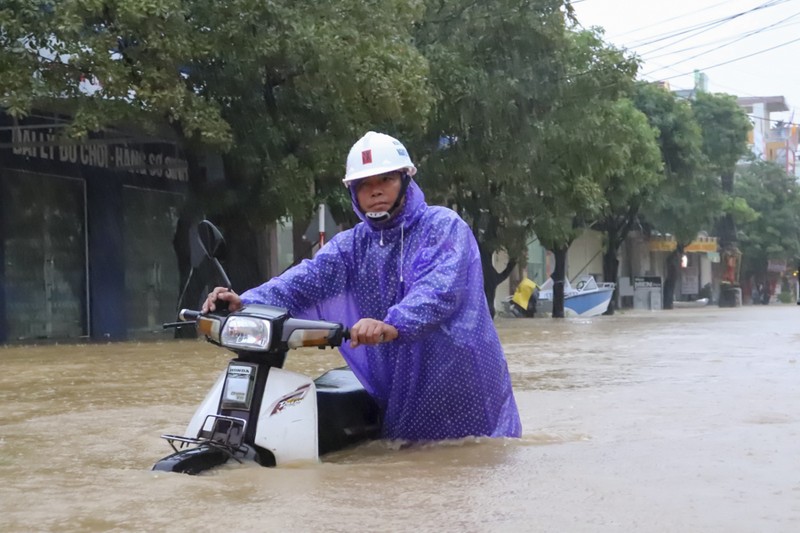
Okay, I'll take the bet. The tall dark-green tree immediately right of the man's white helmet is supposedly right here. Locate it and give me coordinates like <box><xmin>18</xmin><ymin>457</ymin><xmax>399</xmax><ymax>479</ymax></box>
<box><xmin>412</xmin><ymin>0</ymin><xmax>566</xmax><ymax>311</ymax></box>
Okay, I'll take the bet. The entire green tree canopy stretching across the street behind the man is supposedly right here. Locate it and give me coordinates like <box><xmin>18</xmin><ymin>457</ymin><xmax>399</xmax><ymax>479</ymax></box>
<box><xmin>0</xmin><ymin>0</ymin><xmax>776</xmax><ymax>286</ymax></box>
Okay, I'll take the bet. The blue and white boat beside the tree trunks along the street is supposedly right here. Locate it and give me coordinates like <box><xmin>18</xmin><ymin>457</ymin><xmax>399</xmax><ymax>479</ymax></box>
<box><xmin>536</xmin><ymin>274</ymin><xmax>615</xmax><ymax>317</ymax></box>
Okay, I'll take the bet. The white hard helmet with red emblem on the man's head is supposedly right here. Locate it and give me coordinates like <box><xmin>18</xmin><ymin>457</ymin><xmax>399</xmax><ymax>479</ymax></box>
<box><xmin>342</xmin><ymin>131</ymin><xmax>417</xmax><ymax>186</ymax></box>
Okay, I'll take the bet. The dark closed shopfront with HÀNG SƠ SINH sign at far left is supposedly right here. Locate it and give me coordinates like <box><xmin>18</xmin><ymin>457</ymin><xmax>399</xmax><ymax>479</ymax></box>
<box><xmin>0</xmin><ymin>112</ymin><xmax>188</xmax><ymax>343</ymax></box>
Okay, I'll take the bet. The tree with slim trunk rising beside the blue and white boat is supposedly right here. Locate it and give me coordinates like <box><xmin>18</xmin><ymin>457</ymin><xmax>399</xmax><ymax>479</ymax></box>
<box><xmin>524</xmin><ymin>31</ymin><xmax>640</xmax><ymax>318</ymax></box>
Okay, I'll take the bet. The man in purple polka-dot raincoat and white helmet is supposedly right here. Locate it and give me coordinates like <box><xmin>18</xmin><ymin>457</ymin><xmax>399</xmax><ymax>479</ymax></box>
<box><xmin>203</xmin><ymin>132</ymin><xmax>522</xmax><ymax>442</ymax></box>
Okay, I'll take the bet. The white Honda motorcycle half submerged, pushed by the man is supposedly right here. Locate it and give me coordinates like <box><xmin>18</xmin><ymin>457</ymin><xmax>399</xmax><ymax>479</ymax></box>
<box><xmin>153</xmin><ymin>221</ymin><xmax>381</xmax><ymax>474</ymax></box>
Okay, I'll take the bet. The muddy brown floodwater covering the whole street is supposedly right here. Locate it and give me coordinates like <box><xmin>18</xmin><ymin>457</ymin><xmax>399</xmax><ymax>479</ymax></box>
<box><xmin>0</xmin><ymin>304</ymin><xmax>800</xmax><ymax>533</ymax></box>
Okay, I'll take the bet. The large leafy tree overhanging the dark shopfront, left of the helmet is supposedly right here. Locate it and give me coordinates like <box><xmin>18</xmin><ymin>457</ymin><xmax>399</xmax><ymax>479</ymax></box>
<box><xmin>0</xmin><ymin>0</ymin><xmax>431</xmax><ymax>296</ymax></box>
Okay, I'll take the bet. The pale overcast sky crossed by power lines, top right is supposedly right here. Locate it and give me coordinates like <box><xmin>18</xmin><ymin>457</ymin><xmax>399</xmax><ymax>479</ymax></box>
<box><xmin>573</xmin><ymin>0</ymin><xmax>800</xmax><ymax>123</ymax></box>
